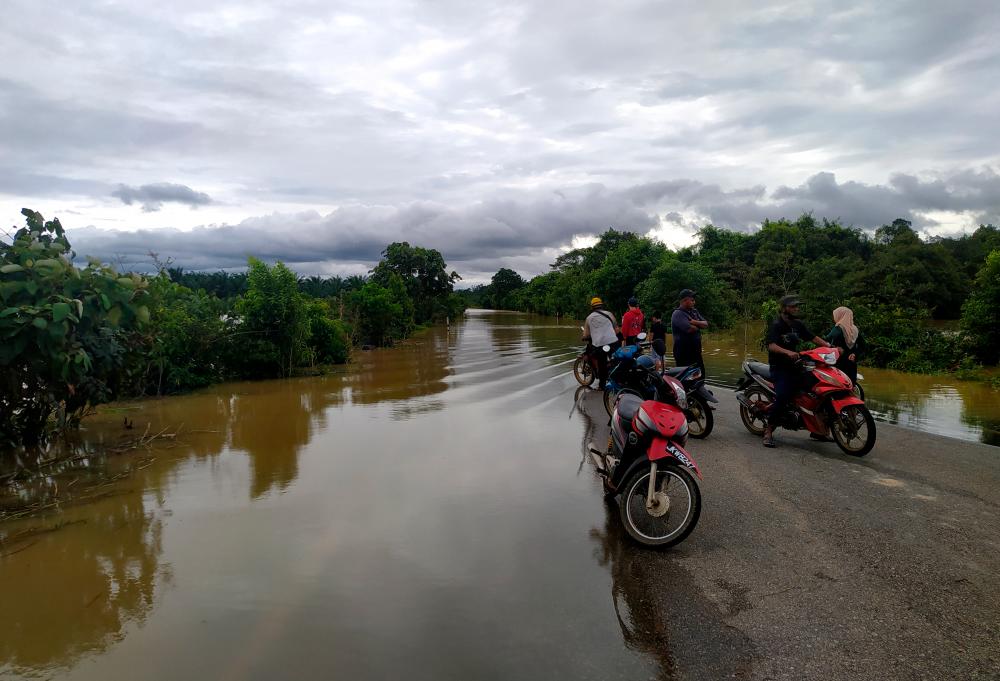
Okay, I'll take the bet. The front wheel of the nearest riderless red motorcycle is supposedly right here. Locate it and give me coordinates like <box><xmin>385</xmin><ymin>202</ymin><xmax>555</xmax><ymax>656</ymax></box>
<box><xmin>618</xmin><ymin>464</ymin><xmax>701</xmax><ymax>548</ymax></box>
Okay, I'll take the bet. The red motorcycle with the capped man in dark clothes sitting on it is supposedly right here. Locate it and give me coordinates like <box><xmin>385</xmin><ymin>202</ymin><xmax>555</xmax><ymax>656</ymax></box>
<box><xmin>736</xmin><ymin>348</ymin><xmax>875</xmax><ymax>456</ymax></box>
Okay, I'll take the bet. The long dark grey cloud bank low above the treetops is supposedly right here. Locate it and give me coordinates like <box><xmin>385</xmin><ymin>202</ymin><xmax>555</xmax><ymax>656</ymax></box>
<box><xmin>71</xmin><ymin>168</ymin><xmax>1000</xmax><ymax>274</ymax></box>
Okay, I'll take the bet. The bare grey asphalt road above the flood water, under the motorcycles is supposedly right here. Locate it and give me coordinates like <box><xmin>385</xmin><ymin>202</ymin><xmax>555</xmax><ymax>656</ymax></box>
<box><xmin>587</xmin><ymin>389</ymin><xmax>1000</xmax><ymax>681</ymax></box>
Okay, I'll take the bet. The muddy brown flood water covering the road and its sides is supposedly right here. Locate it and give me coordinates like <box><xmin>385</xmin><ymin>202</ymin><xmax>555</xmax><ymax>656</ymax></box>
<box><xmin>0</xmin><ymin>311</ymin><xmax>1000</xmax><ymax>680</ymax></box>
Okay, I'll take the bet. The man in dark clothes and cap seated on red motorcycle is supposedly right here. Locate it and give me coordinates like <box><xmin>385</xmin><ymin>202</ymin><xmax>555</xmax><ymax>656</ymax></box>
<box><xmin>764</xmin><ymin>296</ymin><xmax>830</xmax><ymax>447</ymax></box>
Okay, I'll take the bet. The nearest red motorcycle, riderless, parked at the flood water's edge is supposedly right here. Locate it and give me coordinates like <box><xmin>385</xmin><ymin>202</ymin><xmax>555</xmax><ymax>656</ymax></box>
<box><xmin>588</xmin><ymin>376</ymin><xmax>701</xmax><ymax>548</ymax></box>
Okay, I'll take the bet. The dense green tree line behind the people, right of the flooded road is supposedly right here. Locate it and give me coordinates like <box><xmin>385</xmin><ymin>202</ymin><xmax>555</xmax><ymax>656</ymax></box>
<box><xmin>461</xmin><ymin>214</ymin><xmax>1000</xmax><ymax>372</ymax></box>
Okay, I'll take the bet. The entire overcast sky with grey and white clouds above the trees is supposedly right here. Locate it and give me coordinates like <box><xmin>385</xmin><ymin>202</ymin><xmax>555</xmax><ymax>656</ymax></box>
<box><xmin>0</xmin><ymin>0</ymin><xmax>1000</xmax><ymax>282</ymax></box>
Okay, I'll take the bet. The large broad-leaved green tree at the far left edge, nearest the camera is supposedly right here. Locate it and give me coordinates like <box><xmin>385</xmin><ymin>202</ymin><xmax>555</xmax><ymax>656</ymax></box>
<box><xmin>0</xmin><ymin>208</ymin><xmax>149</xmax><ymax>445</ymax></box>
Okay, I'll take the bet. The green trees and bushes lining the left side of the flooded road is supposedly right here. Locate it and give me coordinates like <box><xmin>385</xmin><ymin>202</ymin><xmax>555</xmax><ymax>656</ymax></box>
<box><xmin>0</xmin><ymin>209</ymin><xmax>465</xmax><ymax>448</ymax></box>
